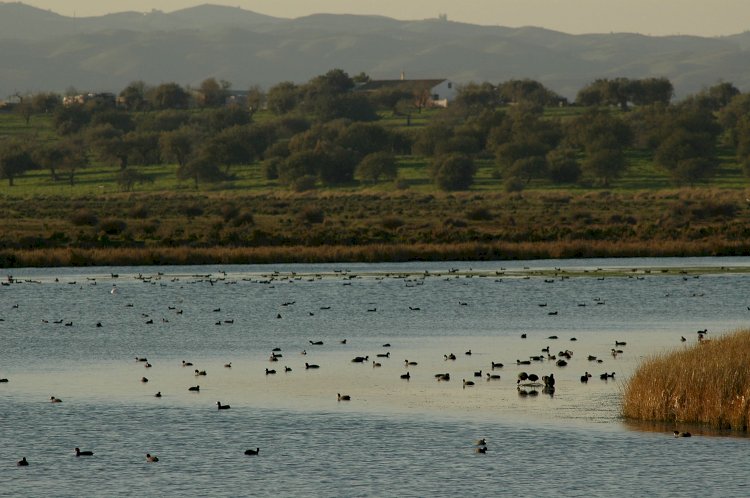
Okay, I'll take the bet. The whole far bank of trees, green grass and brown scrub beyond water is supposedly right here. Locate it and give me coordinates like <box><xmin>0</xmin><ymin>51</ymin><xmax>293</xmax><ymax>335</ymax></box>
<box><xmin>0</xmin><ymin>70</ymin><xmax>750</xmax><ymax>266</ymax></box>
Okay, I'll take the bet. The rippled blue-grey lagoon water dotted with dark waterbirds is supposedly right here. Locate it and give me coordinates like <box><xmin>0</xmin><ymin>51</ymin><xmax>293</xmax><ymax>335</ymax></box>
<box><xmin>0</xmin><ymin>258</ymin><xmax>750</xmax><ymax>496</ymax></box>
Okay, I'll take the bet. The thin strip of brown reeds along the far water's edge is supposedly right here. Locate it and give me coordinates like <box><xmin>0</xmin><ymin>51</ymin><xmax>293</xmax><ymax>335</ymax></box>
<box><xmin>0</xmin><ymin>241</ymin><xmax>750</xmax><ymax>268</ymax></box>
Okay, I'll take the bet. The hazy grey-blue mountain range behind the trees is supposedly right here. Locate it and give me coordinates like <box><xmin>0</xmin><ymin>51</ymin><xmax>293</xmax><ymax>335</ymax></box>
<box><xmin>0</xmin><ymin>3</ymin><xmax>750</xmax><ymax>99</ymax></box>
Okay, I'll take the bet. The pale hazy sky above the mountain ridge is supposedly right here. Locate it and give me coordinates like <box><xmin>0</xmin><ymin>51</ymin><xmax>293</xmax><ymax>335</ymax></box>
<box><xmin>24</xmin><ymin>0</ymin><xmax>750</xmax><ymax>36</ymax></box>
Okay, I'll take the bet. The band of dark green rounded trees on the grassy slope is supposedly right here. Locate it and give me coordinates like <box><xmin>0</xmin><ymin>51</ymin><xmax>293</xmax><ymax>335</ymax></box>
<box><xmin>0</xmin><ymin>69</ymin><xmax>750</xmax><ymax>191</ymax></box>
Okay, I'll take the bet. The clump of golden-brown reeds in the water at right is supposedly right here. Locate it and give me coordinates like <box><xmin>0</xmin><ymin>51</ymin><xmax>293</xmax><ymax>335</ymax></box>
<box><xmin>622</xmin><ymin>330</ymin><xmax>750</xmax><ymax>432</ymax></box>
